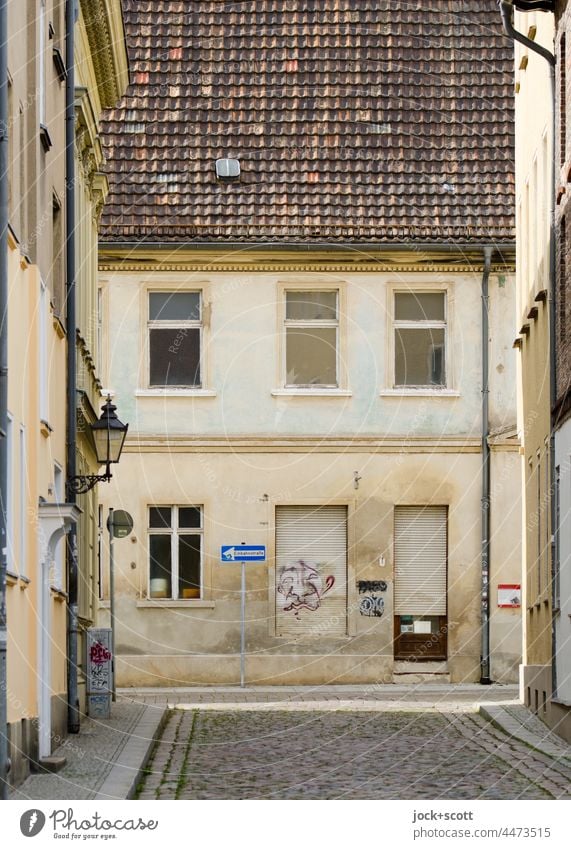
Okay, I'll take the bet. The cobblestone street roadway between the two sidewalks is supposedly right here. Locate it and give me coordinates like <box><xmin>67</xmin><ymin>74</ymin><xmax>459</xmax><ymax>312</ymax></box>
<box><xmin>137</xmin><ymin>708</ymin><xmax>571</xmax><ymax>799</ymax></box>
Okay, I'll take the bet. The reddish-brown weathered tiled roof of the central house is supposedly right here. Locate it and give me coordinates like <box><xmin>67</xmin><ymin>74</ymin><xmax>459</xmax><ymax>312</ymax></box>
<box><xmin>101</xmin><ymin>0</ymin><xmax>514</xmax><ymax>243</ymax></box>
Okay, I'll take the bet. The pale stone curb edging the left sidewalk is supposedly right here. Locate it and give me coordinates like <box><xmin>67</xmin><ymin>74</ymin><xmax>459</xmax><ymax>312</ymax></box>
<box><xmin>93</xmin><ymin>705</ymin><xmax>167</xmax><ymax>800</ymax></box>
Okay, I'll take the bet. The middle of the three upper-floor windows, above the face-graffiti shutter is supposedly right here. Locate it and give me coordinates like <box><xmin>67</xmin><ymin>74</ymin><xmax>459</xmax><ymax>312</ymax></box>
<box><xmin>285</xmin><ymin>291</ymin><xmax>339</xmax><ymax>387</ymax></box>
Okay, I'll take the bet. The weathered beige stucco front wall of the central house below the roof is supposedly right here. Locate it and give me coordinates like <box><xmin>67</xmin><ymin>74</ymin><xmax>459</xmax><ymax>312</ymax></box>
<box><xmin>100</xmin><ymin>262</ymin><xmax>521</xmax><ymax>686</ymax></box>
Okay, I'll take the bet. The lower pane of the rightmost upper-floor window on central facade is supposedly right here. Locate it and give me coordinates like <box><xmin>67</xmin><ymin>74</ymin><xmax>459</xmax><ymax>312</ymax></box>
<box><xmin>395</xmin><ymin>328</ymin><xmax>446</xmax><ymax>386</ymax></box>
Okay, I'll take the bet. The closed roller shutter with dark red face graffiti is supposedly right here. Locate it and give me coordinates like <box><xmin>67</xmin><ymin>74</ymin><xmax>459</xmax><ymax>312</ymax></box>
<box><xmin>276</xmin><ymin>506</ymin><xmax>347</xmax><ymax>637</ymax></box>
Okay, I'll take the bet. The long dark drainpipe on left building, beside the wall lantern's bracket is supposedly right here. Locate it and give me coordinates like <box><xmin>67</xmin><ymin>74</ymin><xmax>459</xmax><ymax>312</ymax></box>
<box><xmin>65</xmin><ymin>0</ymin><xmax>80</xmax><ymax>734</ymax></box>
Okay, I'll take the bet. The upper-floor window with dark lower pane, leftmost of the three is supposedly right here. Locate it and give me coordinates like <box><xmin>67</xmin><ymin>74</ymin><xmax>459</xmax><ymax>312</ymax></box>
<box><xmin>149</xmin><ymin>292</ymin><xmax>202</xmax><ymax>388</ymax></box>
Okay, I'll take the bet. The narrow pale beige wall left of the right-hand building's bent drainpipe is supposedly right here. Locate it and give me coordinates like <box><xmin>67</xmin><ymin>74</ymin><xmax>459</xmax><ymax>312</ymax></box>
<box><xmin>514</xmin><ymin>13</ymin><xmax>554</xmax><ymax>688</ymax></box>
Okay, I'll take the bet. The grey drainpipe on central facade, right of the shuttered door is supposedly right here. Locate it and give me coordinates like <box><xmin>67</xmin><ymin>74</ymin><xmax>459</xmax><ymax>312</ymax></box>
<box><xmin>480</xmin><ymin>247</ymin><xmax>493</xmax><ymax>684</ymax></box>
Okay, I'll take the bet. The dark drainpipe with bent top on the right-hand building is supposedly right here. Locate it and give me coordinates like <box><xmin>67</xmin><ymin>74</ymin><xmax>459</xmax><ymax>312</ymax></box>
<box><xmin>500</xmin><ymin>0</ymin><xmax>557</xmax><ymax>698</ymax></box>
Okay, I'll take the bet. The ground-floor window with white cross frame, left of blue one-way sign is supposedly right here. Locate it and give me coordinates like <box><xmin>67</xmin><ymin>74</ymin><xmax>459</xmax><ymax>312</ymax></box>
<box><xmin>149</xmin><ymin>506</ymin><xmax>203</xmax><ymax>599</ymax></box>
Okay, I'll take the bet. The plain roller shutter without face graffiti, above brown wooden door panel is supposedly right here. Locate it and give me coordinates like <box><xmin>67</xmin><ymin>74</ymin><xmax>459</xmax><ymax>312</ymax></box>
<box><xmin>395</xmin><ymin>507</ymin><xmax>448</xmax><ymax>616</ymax></box>
